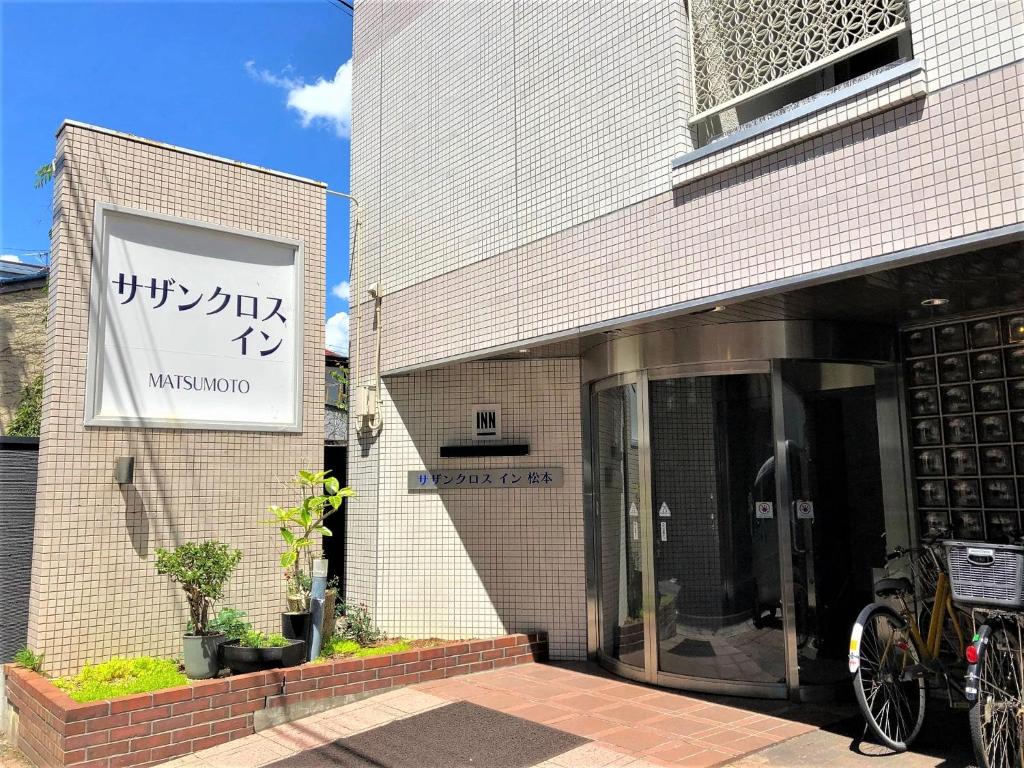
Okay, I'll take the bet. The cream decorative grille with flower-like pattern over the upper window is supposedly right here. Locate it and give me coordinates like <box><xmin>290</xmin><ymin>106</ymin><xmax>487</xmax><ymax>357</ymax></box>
<box><xmin>690</xmin><ymin>0</ymin><xmax>906</xmax><ymax>114</ymax></box>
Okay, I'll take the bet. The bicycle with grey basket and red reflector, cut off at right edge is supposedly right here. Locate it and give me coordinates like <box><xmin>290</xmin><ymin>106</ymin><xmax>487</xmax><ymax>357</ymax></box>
<box><xmin>957</xmin><ymin>544</ymin><xmax>1024</xmax><ymax>768</ymax></box>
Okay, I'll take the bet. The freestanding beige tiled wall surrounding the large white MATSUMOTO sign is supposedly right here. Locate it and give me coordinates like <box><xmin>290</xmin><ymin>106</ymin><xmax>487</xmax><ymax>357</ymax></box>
<box><xmin>29</xmin><ymin>124</ymin><xmax>325</xmax><ymax>673</ymax></box>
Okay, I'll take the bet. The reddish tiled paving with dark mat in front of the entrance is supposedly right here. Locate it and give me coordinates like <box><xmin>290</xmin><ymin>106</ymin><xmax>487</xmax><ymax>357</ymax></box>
<box><xmin>161</xmin><ymin>665</ymin><xmax>965</xmax><ymax>768</ymax></box>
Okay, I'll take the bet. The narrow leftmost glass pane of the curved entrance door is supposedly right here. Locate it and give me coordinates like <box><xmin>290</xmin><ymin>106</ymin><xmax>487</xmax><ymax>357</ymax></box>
<box><xmin>592</xmin><ymin>384</ymin><xmax>645</xmax><ymax>669</ymax></box>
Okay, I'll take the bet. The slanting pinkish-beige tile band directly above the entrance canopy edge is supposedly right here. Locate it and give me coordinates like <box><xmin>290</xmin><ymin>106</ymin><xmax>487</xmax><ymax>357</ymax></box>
<box><xmin>372</xmin><ymin>57</ymin><xmax>1024</xmax><ymax>371</ymax></box>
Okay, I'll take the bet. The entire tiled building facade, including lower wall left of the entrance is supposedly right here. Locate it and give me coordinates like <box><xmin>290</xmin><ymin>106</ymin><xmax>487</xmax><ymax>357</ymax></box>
<box><xmin>347</xmin><ymin>0</ymin><xmax>1024</xmax><ymax>675</ymax></box>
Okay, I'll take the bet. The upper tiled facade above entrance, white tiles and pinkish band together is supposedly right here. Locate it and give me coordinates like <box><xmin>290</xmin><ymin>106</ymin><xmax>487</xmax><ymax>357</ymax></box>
<box><xmin>352</xmin><ymin>0</ymin><xmax>1024</xmax><ymax>370</ymax></box>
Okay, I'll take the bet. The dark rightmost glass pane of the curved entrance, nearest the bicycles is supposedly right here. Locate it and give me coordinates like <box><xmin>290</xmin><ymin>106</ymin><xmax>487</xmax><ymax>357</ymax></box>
<box><xmin>775</xmin><ymin>360</ymin><xmax>886</xmax><ymax>686</ymax></box>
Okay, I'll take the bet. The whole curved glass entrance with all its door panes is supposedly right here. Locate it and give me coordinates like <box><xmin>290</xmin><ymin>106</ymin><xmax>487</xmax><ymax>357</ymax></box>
<box><xmin>591</xmin><ymin>360</ymin><xmax>891</xmax><ymax>697</ymax></box>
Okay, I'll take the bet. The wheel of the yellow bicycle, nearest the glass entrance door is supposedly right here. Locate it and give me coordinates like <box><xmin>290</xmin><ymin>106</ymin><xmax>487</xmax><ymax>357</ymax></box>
<box><xmin>850</xmin><ymin>604</ymin><xmax>927</xmax><ymax>752</ymax></box>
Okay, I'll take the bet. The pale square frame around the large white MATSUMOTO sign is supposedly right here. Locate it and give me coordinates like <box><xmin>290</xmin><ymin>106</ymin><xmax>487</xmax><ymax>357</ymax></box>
<box><xmin>83</xmin><ymin>201</ymin><xmax>305</xmax><ymax>432</ymax></box>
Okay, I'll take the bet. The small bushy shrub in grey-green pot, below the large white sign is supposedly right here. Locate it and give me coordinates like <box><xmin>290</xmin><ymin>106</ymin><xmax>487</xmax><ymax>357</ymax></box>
<box><xmin>157</xmin><ymin>541</ymin><xmax>242</xmax><ymax>680</ymax></box>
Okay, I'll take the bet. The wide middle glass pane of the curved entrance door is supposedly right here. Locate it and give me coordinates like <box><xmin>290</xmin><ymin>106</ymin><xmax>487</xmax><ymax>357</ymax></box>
<box><xmin>649</xmin><ymin>374</ymin><xmax>786</xmax><ymax>686</ymax></box>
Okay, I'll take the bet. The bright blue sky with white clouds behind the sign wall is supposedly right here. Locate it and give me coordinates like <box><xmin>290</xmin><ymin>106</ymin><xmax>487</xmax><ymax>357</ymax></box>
<box><xmin>0</xmin><ymin>0</ymin><xmax>352</xmax><ymax>350</ymax></box>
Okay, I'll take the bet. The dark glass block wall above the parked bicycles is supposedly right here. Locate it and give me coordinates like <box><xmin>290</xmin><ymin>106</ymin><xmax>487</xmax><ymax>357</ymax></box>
<box><xmin>902</xmin><ymin>309</ymin><xmax>1024</xmax><ymax>543</ymax></box>
